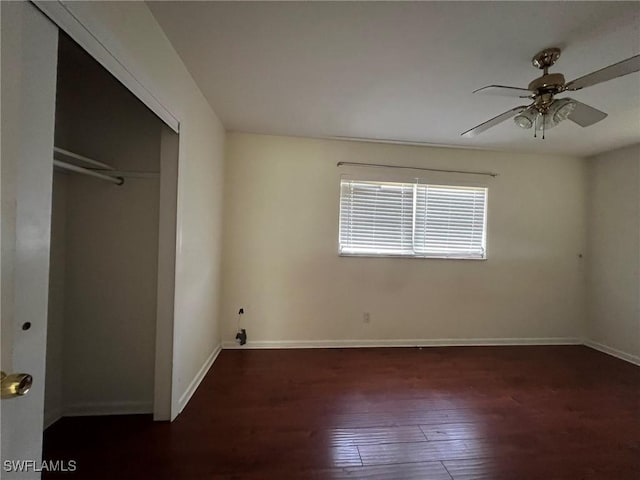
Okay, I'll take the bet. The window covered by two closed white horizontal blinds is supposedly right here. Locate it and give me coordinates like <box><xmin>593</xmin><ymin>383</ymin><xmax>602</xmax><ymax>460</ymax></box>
<box><xmin>339</xmin><ymin>179</ymin><xmax>487</xmax><ymax>259</ymax></box>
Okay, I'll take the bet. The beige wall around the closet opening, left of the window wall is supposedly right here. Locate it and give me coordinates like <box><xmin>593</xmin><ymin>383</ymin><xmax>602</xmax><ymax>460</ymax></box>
<box><xmin>51</xmin><ymin>2</ymin><xmax>225</xmax><ymax>416</ymax></box>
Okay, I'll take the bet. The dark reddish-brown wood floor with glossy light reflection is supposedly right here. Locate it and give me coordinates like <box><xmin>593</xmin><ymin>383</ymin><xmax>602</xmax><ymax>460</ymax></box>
<box><xmin>44</xmin><ymin>346</ymin><xmax>640</xmax><ymax>480</ymax></box>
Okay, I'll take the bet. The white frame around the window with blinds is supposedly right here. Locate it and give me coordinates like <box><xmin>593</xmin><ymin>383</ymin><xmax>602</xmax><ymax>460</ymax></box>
<box><xmin>337</xmin><ymin>174</ymin><xmax>489</xmax><ymax>261</ymax></box>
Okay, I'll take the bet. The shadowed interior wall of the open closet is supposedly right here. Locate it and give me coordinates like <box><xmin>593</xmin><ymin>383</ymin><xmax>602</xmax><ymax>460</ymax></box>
<box><xmin>45</xmin><ymin>34</ymin><xmax>166</xmax><ymax>426</ymax></box>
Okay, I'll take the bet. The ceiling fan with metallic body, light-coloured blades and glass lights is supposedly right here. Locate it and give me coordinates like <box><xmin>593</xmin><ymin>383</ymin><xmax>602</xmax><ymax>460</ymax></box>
<box><xmin>461</xmin><ymin>48</ymin><xmax>640</xmax><ymax>138</ymax></box>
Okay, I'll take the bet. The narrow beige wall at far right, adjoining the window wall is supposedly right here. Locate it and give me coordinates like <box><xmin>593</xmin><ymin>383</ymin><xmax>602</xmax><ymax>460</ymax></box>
<box><xmin>587</xmin><ymin>145</ymin><xmax>640</xmax><ymax>362</ymax></box>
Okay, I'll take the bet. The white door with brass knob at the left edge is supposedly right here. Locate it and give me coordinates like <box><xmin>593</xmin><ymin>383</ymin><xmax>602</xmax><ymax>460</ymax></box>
<box><xmin>0</xmin><ymin>2</ymin><xmax>58</xmax><ymax>479</ymax></box>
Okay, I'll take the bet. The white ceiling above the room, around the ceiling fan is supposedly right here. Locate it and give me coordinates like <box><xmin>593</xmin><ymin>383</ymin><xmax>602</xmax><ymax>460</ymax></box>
<box><xmin>149</xmin><ymin>2</ymin><xmax>640</xmax><ymax>155</ymax></box>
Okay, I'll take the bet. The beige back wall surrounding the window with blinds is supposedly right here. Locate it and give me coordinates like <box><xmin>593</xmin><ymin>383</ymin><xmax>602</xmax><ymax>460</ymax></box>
<box><xmin>221</xmin><ymin>133</ymin><xmax>585</xmax><ymax>345</ymax></box>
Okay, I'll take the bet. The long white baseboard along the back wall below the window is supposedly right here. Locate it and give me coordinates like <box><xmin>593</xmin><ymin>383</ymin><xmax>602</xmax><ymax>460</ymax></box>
<box><xmin>222</xmin><ymin>337</ymin><xmax>582</xmax><ymax>349</ymax></box>
